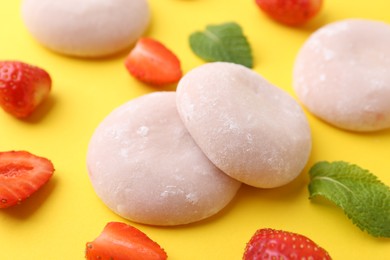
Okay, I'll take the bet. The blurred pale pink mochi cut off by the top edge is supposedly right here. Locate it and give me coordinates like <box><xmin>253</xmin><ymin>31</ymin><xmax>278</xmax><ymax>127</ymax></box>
<box><xmin>22</xmin><ymin>0</ymin><xmax>150</xmax><ymax>57</ymax></box>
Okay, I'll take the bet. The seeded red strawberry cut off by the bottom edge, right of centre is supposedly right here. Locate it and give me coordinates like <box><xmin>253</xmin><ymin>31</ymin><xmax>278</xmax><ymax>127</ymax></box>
<box><xmin>243</xmin><ymin>228</ymin><xmax>331</xmax><ymax>260</ymax></box>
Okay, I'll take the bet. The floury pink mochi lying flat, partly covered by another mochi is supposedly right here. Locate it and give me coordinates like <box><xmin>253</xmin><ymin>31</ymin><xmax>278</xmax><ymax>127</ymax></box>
<box><xmin>87</xmin><ymin>92</ymin><xmax>241</xmax><ymax>225</ymax></box>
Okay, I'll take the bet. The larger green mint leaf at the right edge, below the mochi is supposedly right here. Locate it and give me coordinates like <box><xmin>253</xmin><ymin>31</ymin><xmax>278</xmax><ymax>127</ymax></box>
<box><xmin>309</xmin><ymin>161</ymin><xmax>390</xmax><ymax>237</ymax></box>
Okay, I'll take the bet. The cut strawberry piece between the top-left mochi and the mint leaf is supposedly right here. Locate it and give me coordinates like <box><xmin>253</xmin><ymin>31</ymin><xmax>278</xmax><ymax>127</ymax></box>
<box><xmin>125</xmin><ymin>38</ymin><xmax>182</xmax><ymax>86</ymax></box>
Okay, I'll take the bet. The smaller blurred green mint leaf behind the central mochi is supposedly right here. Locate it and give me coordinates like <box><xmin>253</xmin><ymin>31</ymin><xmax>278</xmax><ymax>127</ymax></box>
<box><xmin>190</xmin><ymin>22</ymin><xmax>253</xmax><ymax>68</ymax></box>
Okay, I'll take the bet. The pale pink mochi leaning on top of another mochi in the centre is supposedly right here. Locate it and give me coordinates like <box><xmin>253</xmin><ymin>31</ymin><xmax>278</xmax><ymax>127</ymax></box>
<box><xmin>176</xmin><ymin>62</ymin><xmax>311</xmax><ymax>188</ymax></box>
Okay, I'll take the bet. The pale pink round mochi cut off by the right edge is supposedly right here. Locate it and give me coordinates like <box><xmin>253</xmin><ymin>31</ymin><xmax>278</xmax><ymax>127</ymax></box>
<box><xmin>293</xmin><ymin>19</ymin><xmax>390</xmax><ymax>131</ymax></box>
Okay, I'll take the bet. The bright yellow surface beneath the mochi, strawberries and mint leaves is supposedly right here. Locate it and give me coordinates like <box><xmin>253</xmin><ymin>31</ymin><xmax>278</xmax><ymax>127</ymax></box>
<box><xmin>0</xmin><ymin>0</ymin><xmax>390</xmax><ymax>260</ymax></box>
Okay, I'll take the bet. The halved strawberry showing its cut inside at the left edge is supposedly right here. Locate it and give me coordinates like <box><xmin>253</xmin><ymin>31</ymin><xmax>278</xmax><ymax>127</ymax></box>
<box><xmin>0</xmin><ymin>151</ymin><xmax>54</xmax><ymax>208</ymax></box>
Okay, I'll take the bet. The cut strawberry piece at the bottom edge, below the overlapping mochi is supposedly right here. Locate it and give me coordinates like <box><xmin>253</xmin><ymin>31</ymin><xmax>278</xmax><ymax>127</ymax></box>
<box><xmin>86</xmin><ymin>222</ymin><xmax>167</xmax><ymax>260</ymax></box>
